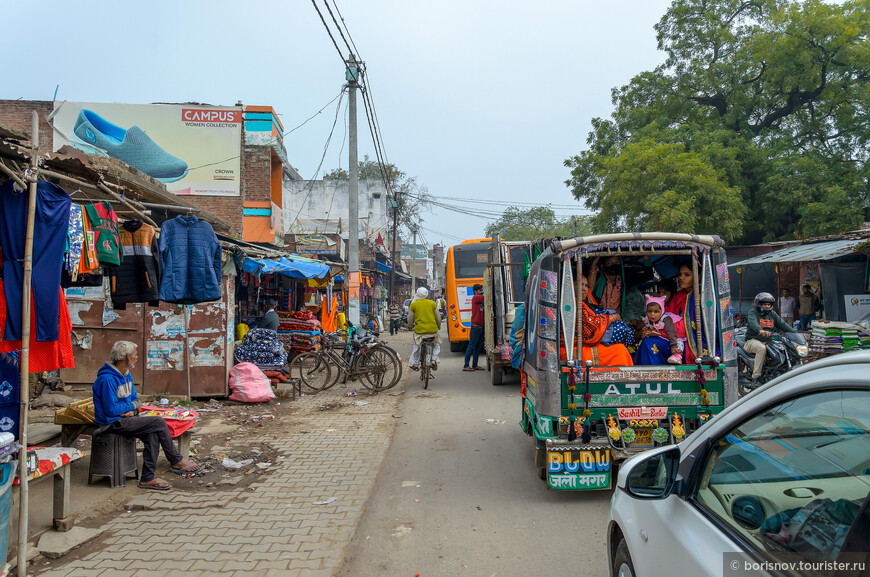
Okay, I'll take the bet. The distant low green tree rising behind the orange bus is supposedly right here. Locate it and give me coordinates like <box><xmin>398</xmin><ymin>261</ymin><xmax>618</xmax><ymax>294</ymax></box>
<box><xmin>485</xmin><ymin>205</ymin><xmax>591</xmax><ymax>240</ymax></box>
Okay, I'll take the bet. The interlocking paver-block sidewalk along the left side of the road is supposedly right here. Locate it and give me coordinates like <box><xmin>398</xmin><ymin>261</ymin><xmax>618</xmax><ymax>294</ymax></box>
<box><xmin>31</xmin><ymin>332</ymin><xmax>411</xmax><ymax>577</ymax></box>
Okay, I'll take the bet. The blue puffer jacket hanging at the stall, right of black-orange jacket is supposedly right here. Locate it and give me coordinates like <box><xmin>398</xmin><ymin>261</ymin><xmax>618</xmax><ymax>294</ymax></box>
<box><xmin>159</xmin><ymin>215</ymin><xmax>221</xmax><ymax>304</ymax></box>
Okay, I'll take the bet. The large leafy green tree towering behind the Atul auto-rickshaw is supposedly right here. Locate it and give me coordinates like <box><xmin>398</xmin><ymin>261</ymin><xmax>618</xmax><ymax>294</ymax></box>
<box><xmin>565</xmin><ymin>0</ymin><xmax>870</xmax><ymax>242</ymax></box>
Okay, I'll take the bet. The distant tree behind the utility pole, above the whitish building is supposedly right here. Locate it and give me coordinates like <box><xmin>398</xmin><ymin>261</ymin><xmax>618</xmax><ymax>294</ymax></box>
<box><xmin>323</xmin><ymin>155</ymin><xmax>431</xmax><ymax>233</ymax></box>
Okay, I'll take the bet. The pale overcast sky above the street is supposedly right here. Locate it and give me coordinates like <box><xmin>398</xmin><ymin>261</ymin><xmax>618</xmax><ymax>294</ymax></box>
<box><xmin>0</xmin><ymin>0</ymin><xmax>670</xmax><ymax>245</ymax></box>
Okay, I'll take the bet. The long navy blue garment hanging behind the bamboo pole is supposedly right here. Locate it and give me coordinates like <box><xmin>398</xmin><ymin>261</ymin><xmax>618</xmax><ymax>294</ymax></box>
<box><xmin>0</xmin><ymin>180</ymin><xmax>72</xmax><ymax>342</ymax></box>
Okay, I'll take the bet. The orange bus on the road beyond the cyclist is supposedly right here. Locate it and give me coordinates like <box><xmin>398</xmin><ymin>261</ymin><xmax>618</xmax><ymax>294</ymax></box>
<box><xmin>444</xmin><ymin>238</ymin><xmax>492</xmax><ymax>352</ymax></box>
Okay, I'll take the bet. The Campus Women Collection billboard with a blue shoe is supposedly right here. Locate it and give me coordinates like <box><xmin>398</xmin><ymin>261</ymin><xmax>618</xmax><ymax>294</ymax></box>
<box><xmin>53</xmin><ymin>101</ymin><xmax>244</xmax><ymax>196</ymax></box>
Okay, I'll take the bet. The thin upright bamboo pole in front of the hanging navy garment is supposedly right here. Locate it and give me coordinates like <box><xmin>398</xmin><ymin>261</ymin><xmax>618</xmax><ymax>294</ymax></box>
<box><xmin>18</xmin><ymin>110</ymin><xmax>39</xmax><ymax>577</ymax></box>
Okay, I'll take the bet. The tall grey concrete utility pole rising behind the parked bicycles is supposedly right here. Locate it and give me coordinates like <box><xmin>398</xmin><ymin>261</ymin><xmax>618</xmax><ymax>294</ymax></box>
<box><xmin>345</xmin><ymin>54</ymin><xmax>360</xmax><ymax>326</ymax></box>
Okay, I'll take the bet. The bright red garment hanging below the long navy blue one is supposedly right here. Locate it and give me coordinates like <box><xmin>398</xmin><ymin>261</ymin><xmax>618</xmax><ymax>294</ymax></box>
<box><xmin>0</xmin><ymin>281</ymin><xmax>76</xmax><ymax>373</ymax></box>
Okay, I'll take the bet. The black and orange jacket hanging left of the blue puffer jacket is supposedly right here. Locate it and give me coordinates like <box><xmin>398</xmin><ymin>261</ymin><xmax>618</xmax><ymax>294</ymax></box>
<box><xmin>110</xmin><ymin>220</ymin><xmax>160</xmax><ymax>310</ymax></box>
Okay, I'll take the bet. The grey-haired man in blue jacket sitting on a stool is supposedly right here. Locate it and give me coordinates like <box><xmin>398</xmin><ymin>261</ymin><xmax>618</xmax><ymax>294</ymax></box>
<box><xmin>94</xmin><ymin>341</ymin><xmax>202</xmax><ymax>491</ymax></box>
